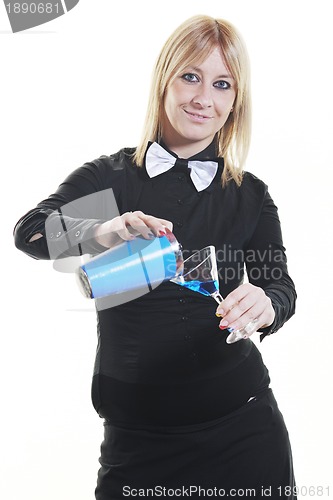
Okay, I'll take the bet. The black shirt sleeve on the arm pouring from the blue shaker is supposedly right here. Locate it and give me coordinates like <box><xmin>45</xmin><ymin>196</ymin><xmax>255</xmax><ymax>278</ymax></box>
<box><xmin>14</xmin><ymin>156</ymin><xmax>123</xmax><ymax>259</ymax></box>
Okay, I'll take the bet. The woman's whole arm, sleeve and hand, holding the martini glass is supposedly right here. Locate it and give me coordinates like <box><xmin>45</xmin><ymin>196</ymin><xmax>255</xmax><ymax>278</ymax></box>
<box><xmin>217</xmin><ymin>189</ymin><xmax>296</xmax><ymax>340</ymax></box>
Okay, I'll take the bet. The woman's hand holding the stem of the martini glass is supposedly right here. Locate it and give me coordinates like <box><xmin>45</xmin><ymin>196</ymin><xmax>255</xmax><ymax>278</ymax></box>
<box><xmin>216</xmin><ymin>283</ymin><xmax>275</xmax><ymax>335</ymax></box>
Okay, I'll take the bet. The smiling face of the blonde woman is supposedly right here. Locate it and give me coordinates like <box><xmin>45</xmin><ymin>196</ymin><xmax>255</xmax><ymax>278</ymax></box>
<box><xmin>162</xmin><ymin>48</ymin><xmax>236</xmax><ymax>158</ymax></box>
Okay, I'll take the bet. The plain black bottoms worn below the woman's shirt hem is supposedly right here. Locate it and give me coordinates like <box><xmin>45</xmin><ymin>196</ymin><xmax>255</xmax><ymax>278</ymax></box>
<box><xmin>96</xmin><ymin>389</ymin><xmax>297</xmax><ymax>500</ymax></box>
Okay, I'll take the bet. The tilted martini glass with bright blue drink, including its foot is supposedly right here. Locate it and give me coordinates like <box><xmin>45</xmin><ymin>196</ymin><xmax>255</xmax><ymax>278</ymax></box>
<box><xmin>170</xmin><ymin>245</ymin><xmax>258</xmax><ymax>344</ymax></box>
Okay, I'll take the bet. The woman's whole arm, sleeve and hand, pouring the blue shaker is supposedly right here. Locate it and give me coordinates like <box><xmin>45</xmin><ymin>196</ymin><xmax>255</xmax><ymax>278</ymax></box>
<box><xmin>14</xmin><ymin>154</ymin><xmax>172</xmax><ymax>259</ymax></box>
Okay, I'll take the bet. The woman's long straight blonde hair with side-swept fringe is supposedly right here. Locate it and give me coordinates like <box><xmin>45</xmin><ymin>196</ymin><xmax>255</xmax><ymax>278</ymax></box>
<box><xmin>134</xmin><ymin>15</ymin><xmax>251</xmax><ymax>186</ymax></box>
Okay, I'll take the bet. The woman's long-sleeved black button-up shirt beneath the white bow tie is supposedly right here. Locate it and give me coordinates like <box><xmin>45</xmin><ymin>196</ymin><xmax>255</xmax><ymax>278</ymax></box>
<box><xmin>15</xmin><ymin>144</ymin><xmax>296</xmax><ymax>426</ymax></box>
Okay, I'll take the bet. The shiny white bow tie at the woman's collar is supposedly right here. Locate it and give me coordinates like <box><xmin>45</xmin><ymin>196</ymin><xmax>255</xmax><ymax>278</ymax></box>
<box><xmin>146</xmin><ymin>142</ymin><xmax>218</xmax><ymax>191</ymax></box>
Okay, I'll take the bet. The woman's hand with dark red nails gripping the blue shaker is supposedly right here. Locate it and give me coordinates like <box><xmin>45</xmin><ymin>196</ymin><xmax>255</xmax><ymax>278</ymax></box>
<box><xmin>95</xmin><ymin>210</ymin><xmax>173</xmax><ymax>248</ymax></box>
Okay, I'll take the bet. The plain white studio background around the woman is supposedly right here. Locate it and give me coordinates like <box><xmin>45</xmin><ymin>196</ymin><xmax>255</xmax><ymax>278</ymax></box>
<box><xmin>0</xmin><ymin>0</ymin><xmax>333</xmax><ymax>500</ymax></box>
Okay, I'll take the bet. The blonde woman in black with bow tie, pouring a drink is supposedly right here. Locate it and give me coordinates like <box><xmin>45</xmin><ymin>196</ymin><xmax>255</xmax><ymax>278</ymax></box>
<box><xmin>15</xmin><ymin>16</ymin><xmax>296</xmax><ymax>500</ymax></box>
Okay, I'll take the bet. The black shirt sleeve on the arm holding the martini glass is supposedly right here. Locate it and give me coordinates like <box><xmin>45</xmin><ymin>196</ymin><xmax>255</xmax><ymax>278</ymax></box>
<box><xmin>245</xmin><ymin>187</ymin><xmax>296</xmax><ymax>340</ymax></box>
